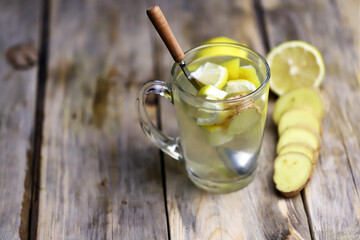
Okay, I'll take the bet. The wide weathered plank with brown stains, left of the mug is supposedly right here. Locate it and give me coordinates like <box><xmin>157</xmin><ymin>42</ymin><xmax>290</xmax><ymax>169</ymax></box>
<box><xmin>37</xmin><ymin>0</ymin><xmax>167</xmax><ymax>239</ymax></box>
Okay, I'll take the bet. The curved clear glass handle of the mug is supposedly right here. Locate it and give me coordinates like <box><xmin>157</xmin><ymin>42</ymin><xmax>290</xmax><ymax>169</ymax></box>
<box><xmin>136</xmin><ymin>80</ymin><xmax>184</xmax><ymax>161</ymax></box>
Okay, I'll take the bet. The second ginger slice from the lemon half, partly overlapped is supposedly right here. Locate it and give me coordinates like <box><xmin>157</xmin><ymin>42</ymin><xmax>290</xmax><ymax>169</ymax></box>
<box><xmin>278</xmin><ymin>107</ymin><xmax>322</xmax><ymax>135</ymax></box>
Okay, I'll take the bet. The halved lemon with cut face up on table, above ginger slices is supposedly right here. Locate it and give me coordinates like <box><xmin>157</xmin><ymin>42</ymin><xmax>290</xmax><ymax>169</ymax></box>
<box><xmin>266</xmin><ymin>41</ymin><xmax>325</xmax><ymax>95</ymax></box>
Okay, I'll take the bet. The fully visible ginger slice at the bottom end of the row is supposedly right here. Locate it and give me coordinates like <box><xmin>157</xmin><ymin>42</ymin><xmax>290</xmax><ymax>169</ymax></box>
<box><xmin>273</xmin><ymin>153</ymin><xmax>312</xmax><ymax>197</ymax></box>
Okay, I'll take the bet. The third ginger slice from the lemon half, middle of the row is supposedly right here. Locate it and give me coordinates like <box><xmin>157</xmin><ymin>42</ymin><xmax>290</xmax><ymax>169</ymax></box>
<box><xmin>276</xmin><ymin>126</ymin><xmax>321</xmax><ymax>154</ymax></box>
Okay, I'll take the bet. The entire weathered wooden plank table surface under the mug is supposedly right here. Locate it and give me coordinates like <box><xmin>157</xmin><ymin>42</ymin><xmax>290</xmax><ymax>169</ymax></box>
<box><xmin>0</xmin><ymin>0</ymin><xmax>360</xmax><ymax>240</ymax></box>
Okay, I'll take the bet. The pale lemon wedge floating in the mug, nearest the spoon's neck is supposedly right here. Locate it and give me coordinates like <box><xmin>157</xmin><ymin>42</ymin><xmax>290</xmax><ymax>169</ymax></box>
<box><xmin>191</xmin><ymin>62</ymin><xmax>229</xmax><ymax>89</ymax></box>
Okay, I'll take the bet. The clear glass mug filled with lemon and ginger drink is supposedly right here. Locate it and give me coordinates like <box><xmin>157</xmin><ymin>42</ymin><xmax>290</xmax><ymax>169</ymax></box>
<box><xmin>136</xmin><ymin>43</ymin><xmax>270</xmax><ymax>193</ymax></box>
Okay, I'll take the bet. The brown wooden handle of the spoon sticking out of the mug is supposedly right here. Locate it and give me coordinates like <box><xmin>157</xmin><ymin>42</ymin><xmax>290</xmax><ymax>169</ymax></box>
<box><xmin>146</xmin><ymin>5</ymin><xmax>185</xmax><ymax>63</ymax></box>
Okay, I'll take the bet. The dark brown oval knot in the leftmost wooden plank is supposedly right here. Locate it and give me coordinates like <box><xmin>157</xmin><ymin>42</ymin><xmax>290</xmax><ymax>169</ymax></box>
<box><xmin>5</xmin><ymin>44</ymin><xmax>38</xmax><ymax>70</ymax></box>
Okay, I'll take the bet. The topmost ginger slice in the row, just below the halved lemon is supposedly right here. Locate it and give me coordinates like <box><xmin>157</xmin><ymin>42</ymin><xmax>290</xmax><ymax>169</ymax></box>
<box><xmin>273</xmin><ymin>87</ymin><xmax>324</xmax><ymax>124</ymax></box>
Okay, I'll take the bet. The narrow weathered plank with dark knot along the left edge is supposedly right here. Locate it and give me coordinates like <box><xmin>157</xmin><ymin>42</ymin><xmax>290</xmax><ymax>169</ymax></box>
<box><xmin>0</xmin><ymin>1</ymin><xmax>40</xmax><ymax>240</ymax></box>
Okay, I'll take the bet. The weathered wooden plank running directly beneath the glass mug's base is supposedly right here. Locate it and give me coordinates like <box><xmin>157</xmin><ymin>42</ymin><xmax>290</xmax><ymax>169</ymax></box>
<box><xmin>150</xmin><ymin>1</ymin><xmax>310</xmax><ymax>239</ymax></box>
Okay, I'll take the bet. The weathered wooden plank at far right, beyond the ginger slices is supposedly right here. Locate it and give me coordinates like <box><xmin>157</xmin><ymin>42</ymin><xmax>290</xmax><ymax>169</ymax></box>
<box><xmin>263</xmin><ymin>0</ymin><xmax>360</xmax><ymax>239</ymax></box>
